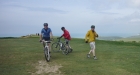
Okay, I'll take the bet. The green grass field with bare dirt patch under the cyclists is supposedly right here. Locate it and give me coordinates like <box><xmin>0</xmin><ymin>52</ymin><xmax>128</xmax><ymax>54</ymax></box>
<box><xmin>0</xmin><ymin>38</ymin><xmax>140</xmax><ymax>75</ymax></box>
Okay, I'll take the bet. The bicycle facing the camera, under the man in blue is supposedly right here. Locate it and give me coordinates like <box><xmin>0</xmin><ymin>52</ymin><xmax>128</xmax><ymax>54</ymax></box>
<box><xmin>41</xmin><ymin>40</ymin><xmax>52</xmax><ymax>62</ymax></box>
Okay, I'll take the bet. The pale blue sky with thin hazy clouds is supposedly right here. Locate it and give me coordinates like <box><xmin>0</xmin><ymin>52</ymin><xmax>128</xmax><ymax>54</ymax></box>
<box><xmin>0</xmin><ymin>0</ymin><xmax>140</xmax><ymax>36</ymax></box>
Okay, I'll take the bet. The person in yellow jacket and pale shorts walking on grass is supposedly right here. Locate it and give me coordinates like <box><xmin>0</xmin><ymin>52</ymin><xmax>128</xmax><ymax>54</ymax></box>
<box><xmin>85</xmin><ymin>25</ymin><xmax>98</xmax><ymax>59</ymax></box>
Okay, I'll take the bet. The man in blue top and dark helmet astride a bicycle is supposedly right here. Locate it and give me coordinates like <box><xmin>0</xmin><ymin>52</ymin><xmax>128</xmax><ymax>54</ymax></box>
<box><xmin>40</xmin><ymin>23</ymin><xmax>53</xmax><ymax>49</ymax></box>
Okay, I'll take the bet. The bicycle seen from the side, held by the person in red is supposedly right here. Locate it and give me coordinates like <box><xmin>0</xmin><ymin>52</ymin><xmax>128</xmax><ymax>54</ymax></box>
<box><xmin>51</xmin><ymin>38</ymin><xmax>71</xmax><ymax>55</ymax></box>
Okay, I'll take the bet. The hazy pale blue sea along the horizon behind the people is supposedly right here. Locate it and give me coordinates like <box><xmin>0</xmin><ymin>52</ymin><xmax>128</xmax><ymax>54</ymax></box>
<box><xmin>0</xmin><ymin>33</ymin><xmax>136</xmax><ymax>38</ymax></box>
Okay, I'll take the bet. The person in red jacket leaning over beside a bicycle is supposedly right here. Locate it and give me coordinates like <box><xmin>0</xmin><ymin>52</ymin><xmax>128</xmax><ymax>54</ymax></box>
<box><xmin>59</xmin><ymin>27</ymin><xmax>73</xmax><ymax>51</ymax></box>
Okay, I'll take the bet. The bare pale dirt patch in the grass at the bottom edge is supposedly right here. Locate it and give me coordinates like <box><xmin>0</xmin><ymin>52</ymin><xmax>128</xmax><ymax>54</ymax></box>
<box><xmin>32</xmin><ymin>60</ymin><xmax>63</xmax><ymax>75</ymax></box>
